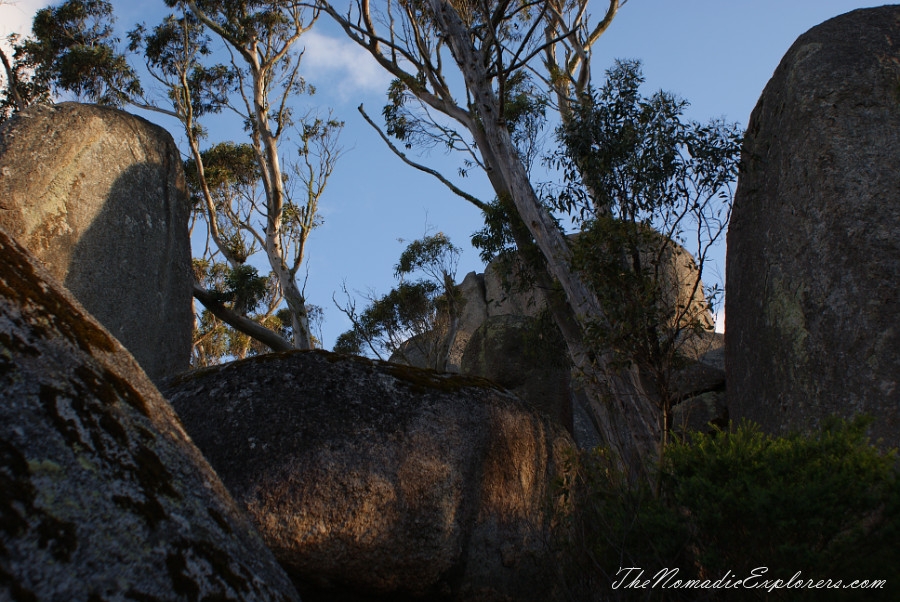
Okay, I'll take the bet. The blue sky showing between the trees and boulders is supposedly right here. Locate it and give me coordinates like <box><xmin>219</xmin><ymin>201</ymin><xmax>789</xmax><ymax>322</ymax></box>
<box><xmin>0</xmin><ymin>0</ymin><xmax>883</xmax><ymax>348</ymax></box>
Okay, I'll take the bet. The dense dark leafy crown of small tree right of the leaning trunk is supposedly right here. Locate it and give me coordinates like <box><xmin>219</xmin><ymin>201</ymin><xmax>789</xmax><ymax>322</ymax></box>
<box><xmin>550</xmin><ymin>61</ymin><xmax>741</xmax><ymax>227</ymax></box>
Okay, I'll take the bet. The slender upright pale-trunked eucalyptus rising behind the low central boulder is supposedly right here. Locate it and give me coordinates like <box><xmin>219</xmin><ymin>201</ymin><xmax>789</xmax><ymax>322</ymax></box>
<box><xmin>158</xmin><ymin>0</ymin><xmax>341</xmax><ymax>349</ymax></box>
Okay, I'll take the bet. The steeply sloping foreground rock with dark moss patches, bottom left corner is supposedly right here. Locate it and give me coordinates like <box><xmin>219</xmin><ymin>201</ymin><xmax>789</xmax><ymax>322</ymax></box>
<box><xmin>0</xmin><ymin>224</ymin><xmax>298</xmax><ymax>602</ymax></box>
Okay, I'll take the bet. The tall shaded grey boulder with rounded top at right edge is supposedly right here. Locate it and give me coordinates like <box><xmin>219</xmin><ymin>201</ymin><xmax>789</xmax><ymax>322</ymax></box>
<box><xmin>726</xmin><ymin>6</ymin><xmax>900</xmax><ymax>446</ymax></box>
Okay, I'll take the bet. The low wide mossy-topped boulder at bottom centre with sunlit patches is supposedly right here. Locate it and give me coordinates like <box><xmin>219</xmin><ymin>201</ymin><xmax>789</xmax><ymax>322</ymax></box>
<box><xmin>163</xmin><ymin>351</ymin><xmax>572</xmax><ymax>601</ymax></box>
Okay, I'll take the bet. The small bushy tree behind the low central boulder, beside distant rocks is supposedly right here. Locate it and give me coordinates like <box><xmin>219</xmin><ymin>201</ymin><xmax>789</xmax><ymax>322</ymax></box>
<box><xmin>334</xmin><ymin>232</ymin><xmax>465</xmax><ymax>370</ymax></box>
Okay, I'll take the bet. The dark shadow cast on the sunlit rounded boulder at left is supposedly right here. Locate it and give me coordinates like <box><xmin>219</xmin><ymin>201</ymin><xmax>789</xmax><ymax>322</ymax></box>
<box><xmin>65</xmin><ymin>163</ymin><xmax>193</xmax><ymax>382</ymax></box>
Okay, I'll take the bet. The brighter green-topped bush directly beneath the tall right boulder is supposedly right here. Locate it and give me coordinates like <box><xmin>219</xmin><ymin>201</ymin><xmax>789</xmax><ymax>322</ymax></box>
<box><xmin>665</xmin><ymin>419</ymin><xmax>900</xmax><ymax>579</ymax></box>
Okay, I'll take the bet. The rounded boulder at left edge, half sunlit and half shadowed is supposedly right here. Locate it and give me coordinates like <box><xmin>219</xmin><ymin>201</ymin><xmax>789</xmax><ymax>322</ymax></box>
<box><xmin>0</xmin><ymin>103</ymin><xmax>193</xmax><ymax>381</ymax></box>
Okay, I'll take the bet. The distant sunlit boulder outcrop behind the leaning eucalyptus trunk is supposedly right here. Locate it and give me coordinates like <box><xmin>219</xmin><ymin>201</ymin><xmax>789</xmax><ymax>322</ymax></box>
<box><xmin>391</xmin><ymin>234</ymin><xmax>724</xmax><ymax>448</ymax></box>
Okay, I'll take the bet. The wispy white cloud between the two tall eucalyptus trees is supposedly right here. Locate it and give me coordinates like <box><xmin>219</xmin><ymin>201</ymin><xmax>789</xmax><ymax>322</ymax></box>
<box><xmin>301</xmin><ymin>31</ymin><xmax>391</xmax><ymax>100</ymax></box>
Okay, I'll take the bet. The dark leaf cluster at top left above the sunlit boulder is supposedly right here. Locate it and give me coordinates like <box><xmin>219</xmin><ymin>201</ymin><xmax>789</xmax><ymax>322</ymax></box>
<box><xmin>24</xmin><ymin>0</ymin><xmax>141</xmax><ymax>106</ymax></box>
